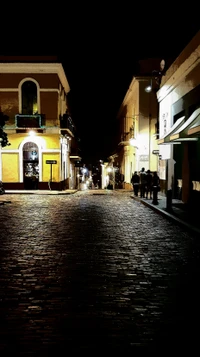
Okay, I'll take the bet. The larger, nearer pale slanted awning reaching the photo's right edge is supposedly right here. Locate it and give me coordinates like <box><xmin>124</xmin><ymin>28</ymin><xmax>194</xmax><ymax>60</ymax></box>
<box><xmin>170</xmin><ymin>108</ymin><xmax>200</xmax><ymax>143</ymax></box>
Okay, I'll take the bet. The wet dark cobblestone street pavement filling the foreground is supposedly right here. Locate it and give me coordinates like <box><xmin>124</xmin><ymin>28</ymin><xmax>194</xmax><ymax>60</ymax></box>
<box><xmin>0</xmin><ymin>191</ymin><xmax>200</xmax><ymax>357</ymax></box>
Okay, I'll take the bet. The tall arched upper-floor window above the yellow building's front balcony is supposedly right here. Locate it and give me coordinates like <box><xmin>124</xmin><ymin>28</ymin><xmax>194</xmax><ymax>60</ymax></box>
<box><xmin>21</xmin><ymin>81</ymin><xmax>38</xmax><ymax>115</ymax></box>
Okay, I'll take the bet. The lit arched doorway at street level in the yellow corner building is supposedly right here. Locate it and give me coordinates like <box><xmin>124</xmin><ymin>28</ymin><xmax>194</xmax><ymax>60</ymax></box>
<box><xmin>23</xmin><ymin>142</ymin><xmax>39</xmax><ymax>190</ymax></box>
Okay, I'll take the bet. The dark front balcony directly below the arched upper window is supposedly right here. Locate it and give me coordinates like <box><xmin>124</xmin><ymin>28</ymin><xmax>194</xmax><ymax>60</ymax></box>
<box><xmin>15</xmin><ymin>114</ymin><xmax>45</xmax><ymax>129</ymax></box>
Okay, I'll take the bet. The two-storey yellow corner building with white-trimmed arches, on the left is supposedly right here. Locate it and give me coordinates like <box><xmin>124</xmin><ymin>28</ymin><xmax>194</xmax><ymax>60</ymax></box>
<box><xmin>0</xmin><ymin>56</ymin><xmax>80</xmax><ymax>190</ymax></box>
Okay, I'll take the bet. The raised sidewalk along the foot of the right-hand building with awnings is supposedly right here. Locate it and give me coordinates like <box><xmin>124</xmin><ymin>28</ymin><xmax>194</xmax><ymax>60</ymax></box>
<box><xmin>131</xmin><ymin>194</ymin><xmax>200</xmax><ymax>236</ymax></box>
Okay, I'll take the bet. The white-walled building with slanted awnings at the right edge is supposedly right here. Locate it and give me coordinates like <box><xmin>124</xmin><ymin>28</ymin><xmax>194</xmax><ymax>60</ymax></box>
<box><xmin>157</xmin><ymin>31</ymin><xmax>200</xmax><ymax>203</ymax></box>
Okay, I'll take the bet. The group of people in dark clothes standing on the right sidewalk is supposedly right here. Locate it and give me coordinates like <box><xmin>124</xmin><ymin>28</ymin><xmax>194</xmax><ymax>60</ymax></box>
<box><xmin>131</xmin><ymin>167</ymin><xmax>160</xmax><ymax>199</ymax></box>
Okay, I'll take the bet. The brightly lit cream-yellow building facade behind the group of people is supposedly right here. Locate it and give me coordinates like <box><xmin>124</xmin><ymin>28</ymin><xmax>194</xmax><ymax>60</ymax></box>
<box><xmin>112</xmin><ymin>76</ymin><xmax>159</xmax><ymax>189</ymax></box>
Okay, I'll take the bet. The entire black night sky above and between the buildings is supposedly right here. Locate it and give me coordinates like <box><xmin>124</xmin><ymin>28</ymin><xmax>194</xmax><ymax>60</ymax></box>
<box><xmin>1</xmin><ymin>2</ymin><xmax>200</xmax><ymax>163</ymax></box>
